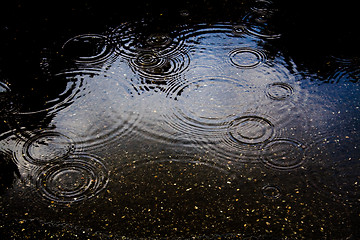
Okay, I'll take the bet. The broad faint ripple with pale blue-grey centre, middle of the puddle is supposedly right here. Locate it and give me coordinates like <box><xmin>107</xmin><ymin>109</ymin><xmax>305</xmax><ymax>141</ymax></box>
<box><xmin>166</xmin><ymin>77</ymin><xmax>253</xmax><ymax>139</ymax></box>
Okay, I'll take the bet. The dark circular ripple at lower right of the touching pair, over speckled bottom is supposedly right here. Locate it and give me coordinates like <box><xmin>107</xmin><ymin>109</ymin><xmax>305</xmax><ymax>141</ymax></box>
<box><xmin>262</xmin><ymin>139</ymin><xmax>305</xmax><ymax>170</ymax></box>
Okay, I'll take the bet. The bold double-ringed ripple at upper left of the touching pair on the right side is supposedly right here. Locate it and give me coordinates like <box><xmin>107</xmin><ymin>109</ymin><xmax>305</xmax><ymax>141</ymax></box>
<box><xmin>228</xmin><ymin>116</ymin><xmax>274</xmax><ymax>144</ymax></box>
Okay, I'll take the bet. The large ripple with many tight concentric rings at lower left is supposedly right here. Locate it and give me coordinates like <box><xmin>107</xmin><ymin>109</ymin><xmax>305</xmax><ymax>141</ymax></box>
<box><xmin>36</xmin><ymin>155</ymin><xmax>109</xmax><ymax>204</ymax></box>
